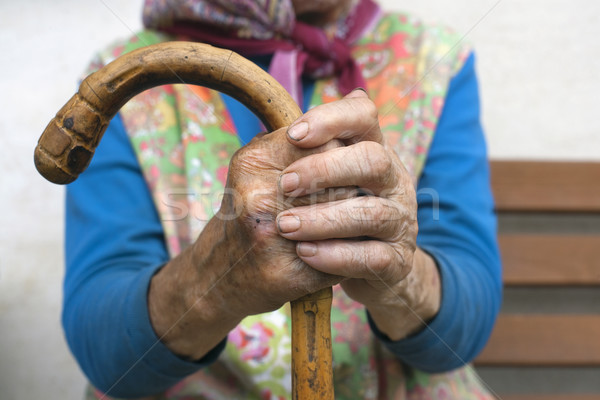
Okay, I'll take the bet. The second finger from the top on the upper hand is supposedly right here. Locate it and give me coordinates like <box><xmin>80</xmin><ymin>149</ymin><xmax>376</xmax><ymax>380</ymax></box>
<box><xmin>279</xmin><ymin>142</ymin><xmax>412</xmax><ymax>196</ymax></box>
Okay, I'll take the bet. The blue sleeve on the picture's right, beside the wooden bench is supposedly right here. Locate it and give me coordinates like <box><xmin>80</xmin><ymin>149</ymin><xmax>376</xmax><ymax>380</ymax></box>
<box><xmin>371</xmin><ymin>54</ymin><xmax>502</xmax><ymax>372</ymax></box>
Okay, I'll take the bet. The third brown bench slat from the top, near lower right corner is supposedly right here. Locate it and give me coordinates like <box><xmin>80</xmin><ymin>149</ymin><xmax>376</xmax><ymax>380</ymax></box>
<box><xmin>476</xmin><ymin>314</ymin><xmax>600</xmax><ymax>367</ymax></box>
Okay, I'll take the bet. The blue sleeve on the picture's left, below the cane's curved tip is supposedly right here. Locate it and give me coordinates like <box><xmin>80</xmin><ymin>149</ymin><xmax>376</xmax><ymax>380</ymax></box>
<box><xmin>62</xmin><ymin>117</ymin><xmax>225</xmax><ymax>397</ymax></box>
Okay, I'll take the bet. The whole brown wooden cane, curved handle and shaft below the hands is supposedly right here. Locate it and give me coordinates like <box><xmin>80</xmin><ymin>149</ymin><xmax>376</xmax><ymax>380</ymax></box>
<box><xmin>34</xmin><ymin>42</ymin><xmax>333</xmax><ymax>399</ymax></box>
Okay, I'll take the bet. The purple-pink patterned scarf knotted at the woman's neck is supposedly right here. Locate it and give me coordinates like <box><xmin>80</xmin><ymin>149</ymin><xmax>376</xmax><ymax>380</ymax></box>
<box><xmin>144</xmin><ymin>0</ymin><xmax>381</xmax><ymax>105</ymax></box>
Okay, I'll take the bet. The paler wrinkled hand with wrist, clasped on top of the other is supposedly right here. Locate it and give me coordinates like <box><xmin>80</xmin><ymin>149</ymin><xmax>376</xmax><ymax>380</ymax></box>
<box><xmin>277</xmin><ymin>90</ymin><xmax>441</xmax><ymax>340</ymax></box>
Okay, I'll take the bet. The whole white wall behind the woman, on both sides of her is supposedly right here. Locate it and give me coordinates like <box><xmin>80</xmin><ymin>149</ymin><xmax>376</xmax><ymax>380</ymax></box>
<box><xmin>0</xmin><ymin>0</ymin><xmax>600</xmax><ymax>399</ymax></box>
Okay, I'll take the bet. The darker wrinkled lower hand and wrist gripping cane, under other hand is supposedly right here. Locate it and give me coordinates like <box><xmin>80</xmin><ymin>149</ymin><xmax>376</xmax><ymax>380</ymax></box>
<box><xmin>148</xmin><ymin>128</ymin><xmax>346</xmax><ymax>360</ymax></box>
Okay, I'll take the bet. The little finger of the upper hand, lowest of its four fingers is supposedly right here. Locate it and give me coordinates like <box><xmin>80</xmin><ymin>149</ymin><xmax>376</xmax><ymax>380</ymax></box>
<box><xmin>296</xmin><ymin>240</ymin><xmax>410</xmax><ymax>282</ymax></box>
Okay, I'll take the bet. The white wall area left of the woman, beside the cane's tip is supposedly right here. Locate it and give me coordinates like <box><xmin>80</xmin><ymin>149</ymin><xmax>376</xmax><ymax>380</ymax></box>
<box><xmin>0</xmin><ymin>0</ymin><xmax>141</xmax><ymax>400</ymax></box>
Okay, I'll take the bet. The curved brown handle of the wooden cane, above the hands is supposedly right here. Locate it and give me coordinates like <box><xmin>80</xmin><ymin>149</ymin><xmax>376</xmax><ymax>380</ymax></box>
<box><xmin>34</xmin><ymin>42</ymin><xmax>302</xmax><ymax>184</ymax></box>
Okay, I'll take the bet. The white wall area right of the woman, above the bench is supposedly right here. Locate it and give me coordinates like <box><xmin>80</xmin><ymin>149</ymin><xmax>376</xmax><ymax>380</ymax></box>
<box><xmin>384</xmin><ymin>0</ymin><xmax>600</xmax><ymax>160</ymax></box>
